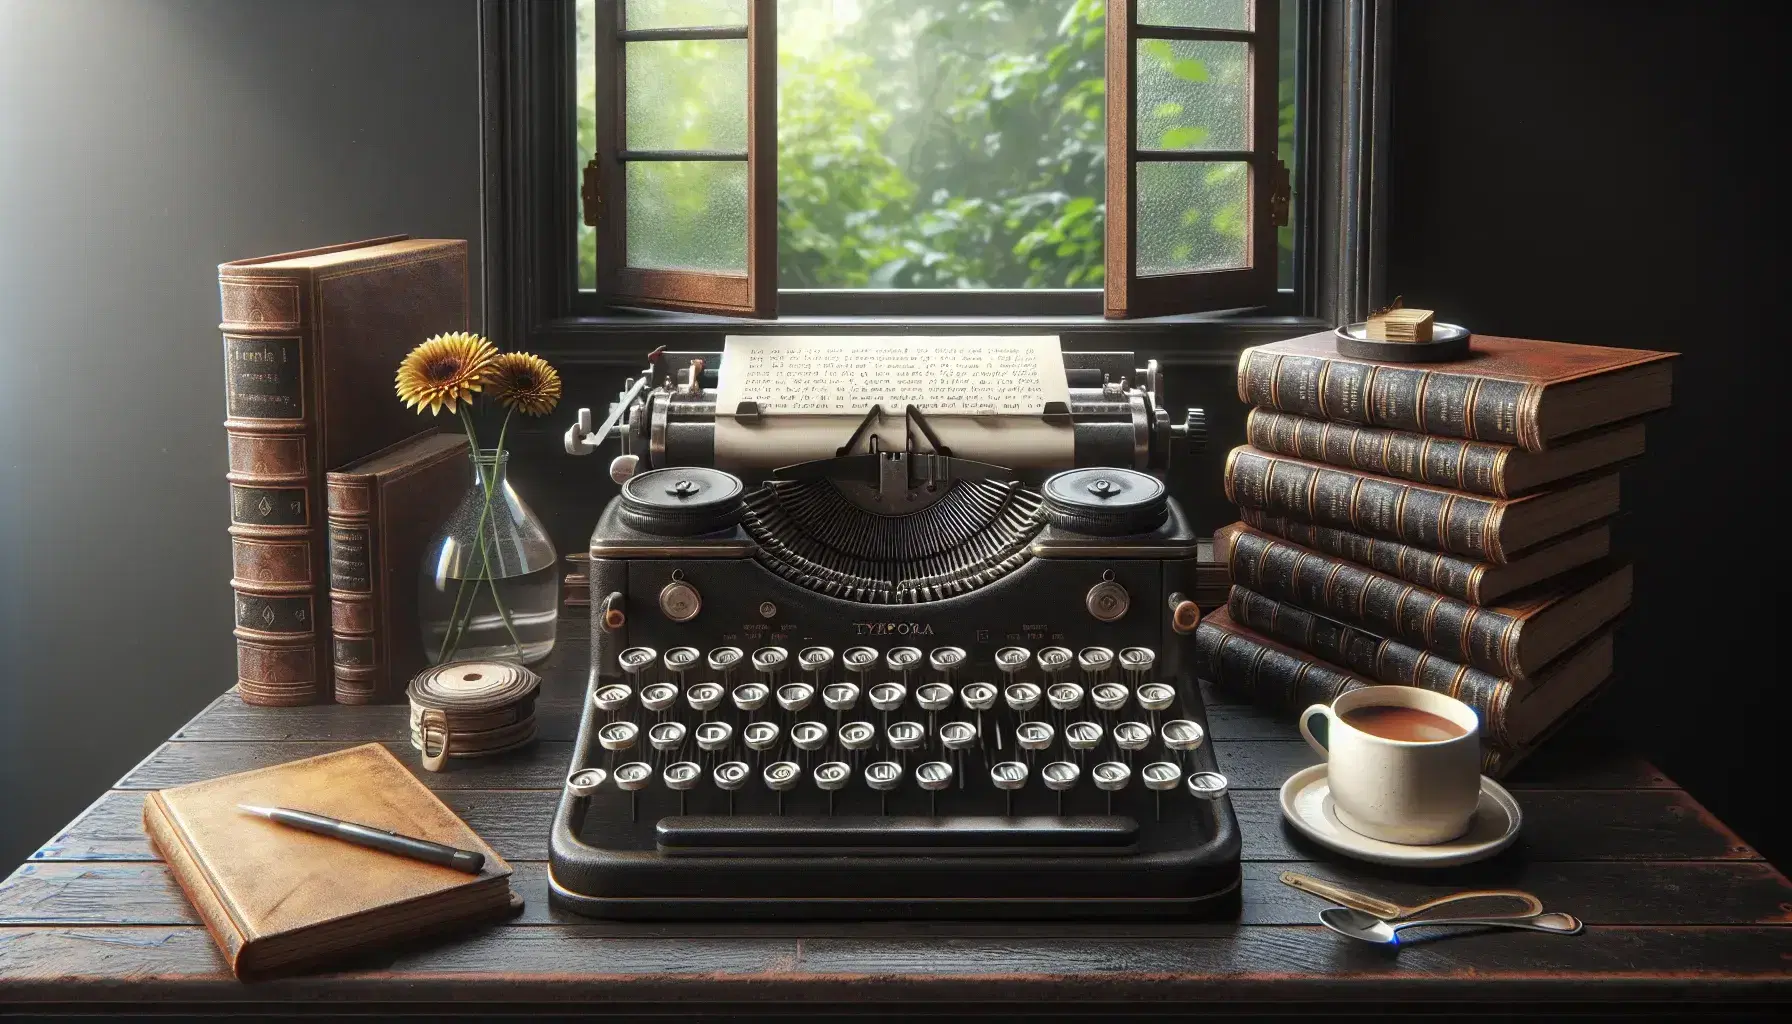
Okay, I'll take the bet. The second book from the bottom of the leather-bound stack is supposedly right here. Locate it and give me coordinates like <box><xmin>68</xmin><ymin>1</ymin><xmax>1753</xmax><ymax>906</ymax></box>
<box><xmin>1226</xmin><ymin>586</ymin><xmax>1613</xmax><ymax>703</ymax></box>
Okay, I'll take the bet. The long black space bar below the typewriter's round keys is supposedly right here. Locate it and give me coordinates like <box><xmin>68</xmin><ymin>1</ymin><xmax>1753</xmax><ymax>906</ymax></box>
<box><xmin>656</xmin><ymin>814</ymin><xmax>1138</xmax><ymax>857</ymax></box>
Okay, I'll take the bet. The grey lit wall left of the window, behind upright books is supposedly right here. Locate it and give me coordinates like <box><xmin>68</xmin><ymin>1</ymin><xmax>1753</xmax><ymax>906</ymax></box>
<box><xmin>0</xmin><ymin>0</ymin><xmax>478</xmax><ymax>870</ymax></box>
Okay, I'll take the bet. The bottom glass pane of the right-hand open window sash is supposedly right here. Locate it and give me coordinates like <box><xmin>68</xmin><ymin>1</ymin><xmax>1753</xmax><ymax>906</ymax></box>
<box><xmin>1133</xmin><ymin>160</ymin><xmax>1249</xmax><ymax>276</ymax></box>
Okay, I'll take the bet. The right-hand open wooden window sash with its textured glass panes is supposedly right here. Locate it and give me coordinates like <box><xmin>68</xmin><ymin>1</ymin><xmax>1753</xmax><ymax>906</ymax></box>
<box><xmin>1104</xmin><ymin>0</ymin><xmax>1288</xmax><ymax>319</ymax></box>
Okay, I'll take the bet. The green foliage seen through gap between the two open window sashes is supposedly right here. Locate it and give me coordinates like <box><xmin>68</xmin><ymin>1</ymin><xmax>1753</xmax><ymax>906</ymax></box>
<box><xmin>778</xmin><ymin>0</ymin><xmax>1106</xmax><ymax>289</ymax></box>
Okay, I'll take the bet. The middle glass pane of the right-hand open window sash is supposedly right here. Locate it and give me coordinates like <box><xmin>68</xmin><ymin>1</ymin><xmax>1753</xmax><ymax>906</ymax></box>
<box><xmin>1138</xmin><ymin>39</ymin><xmax>1251</xmax><ymax>149</ymax></box>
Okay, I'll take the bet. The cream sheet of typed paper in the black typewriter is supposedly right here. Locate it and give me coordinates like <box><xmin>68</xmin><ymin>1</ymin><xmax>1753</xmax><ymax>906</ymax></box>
<box><xmin>715</xmin><ymin>335</ymin><xmax>1075</xmax><ymax>470</ymax></box>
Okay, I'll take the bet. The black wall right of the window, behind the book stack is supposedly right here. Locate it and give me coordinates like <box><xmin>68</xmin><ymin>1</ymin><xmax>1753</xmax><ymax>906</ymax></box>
<box><xmin>1387</xmin><ymin>0</ymin><xmax>1792</xmax><ymax>864</ymax></box>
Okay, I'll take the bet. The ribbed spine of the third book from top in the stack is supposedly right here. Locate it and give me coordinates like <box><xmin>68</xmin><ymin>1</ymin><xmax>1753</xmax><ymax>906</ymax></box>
<box><xmin>1226</xmin><ymin>447</ymin><xmax>1509</xmax><ymax>563</ymax></box>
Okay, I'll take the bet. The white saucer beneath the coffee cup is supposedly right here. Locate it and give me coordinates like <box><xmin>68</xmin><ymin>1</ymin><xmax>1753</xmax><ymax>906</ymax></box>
<box><xmin>1281</xmin><ymin>764</ymin><xmax>1525</xmax><ymax>868</ymax></box>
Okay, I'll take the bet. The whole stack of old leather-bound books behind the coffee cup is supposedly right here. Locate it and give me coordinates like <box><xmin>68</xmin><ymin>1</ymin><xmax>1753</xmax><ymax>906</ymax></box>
<box><xmin>1197</xmin><ymin>332</ymin><xmax>1674</xmax><ymax>777</ymax></box>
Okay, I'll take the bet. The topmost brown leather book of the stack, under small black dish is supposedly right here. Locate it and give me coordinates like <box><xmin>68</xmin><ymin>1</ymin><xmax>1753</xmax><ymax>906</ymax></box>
<box><xmin>1238</xmin><ymin>330</ymin><xmax>1677</xmax><ymax>452</ymax></box>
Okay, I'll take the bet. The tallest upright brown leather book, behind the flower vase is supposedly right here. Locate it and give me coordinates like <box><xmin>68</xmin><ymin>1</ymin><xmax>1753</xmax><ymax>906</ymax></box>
<box><xmin>219</xmin><ymin>235</ymin><xmax>468</xmax><ymax>705</ymax></box>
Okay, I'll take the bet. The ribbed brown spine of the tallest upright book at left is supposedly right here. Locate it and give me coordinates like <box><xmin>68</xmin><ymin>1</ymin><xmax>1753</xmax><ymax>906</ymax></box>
<box><xmin>219</xmin><ymin>265</ymin><xmax>328</xmax><ymax>705</ymax></box>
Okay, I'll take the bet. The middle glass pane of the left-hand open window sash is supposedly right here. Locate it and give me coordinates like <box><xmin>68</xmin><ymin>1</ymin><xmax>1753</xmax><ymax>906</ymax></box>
<box><xmin>624</xmin><ymin>39</ymin><xmax>747</xmax><ymax>152</ymax></box>
